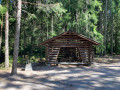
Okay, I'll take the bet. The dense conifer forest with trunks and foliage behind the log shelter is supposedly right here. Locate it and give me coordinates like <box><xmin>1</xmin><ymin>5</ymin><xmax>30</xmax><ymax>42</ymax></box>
<box><xmin>0</xmin><ymin>0</ymin><xmax>120</xmax><ymax>71</ymax></box>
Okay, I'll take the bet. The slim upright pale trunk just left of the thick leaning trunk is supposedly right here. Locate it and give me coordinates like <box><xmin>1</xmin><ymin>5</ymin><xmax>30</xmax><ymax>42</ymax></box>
<box><xmin>5</xmin><ymin>0</ymin><xmax>9</xmax><ymax>69</ymax></box>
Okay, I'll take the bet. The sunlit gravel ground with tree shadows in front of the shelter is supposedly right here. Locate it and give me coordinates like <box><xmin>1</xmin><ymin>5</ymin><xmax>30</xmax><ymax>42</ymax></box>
<box><xmin>0</xmin><ymin>62</ymin><xmax>120</xmax><ymax>90</ymax></box>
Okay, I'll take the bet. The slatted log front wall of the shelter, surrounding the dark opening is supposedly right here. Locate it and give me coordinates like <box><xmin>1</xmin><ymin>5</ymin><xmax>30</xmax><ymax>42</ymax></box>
<box><xmin>47</xmin><ymin>34</ymin><xmax>93</xmax><ymax>64</ymax></box>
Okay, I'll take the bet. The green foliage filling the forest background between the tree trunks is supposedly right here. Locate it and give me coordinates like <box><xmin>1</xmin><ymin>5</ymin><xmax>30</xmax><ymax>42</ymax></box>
<box><xmin>0</xmin><ymin>0</ymin><xmax>120</xmax><ymax>66</ymax></box>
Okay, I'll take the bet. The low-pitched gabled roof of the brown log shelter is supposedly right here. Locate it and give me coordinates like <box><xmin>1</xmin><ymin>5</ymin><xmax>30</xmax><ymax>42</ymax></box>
<box><xmin>41</xmin><ymin>30</ymin><xmax>99</xmax><ymax>45</ymax></box>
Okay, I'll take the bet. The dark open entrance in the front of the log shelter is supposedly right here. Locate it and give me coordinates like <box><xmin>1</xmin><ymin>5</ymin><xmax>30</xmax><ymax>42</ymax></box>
<box><xmin>57</xmin><ymin>47</ymin><xmax>88</xmax><ymax>63</ymax></box>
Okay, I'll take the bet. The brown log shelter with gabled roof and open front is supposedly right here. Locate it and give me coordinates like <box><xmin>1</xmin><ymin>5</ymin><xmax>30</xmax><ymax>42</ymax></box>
<box><xmin>41</xmin><ymin>31</ymin><xmax>99</xmax><ymax>65</ymax></box>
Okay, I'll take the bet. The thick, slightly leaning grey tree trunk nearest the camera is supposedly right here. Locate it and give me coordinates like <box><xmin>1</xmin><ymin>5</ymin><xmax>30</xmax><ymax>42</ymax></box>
<box><xmin>11</xmin><ymin>0</ymin><xmax>22</xmax><ymax>75</ymax></box>
